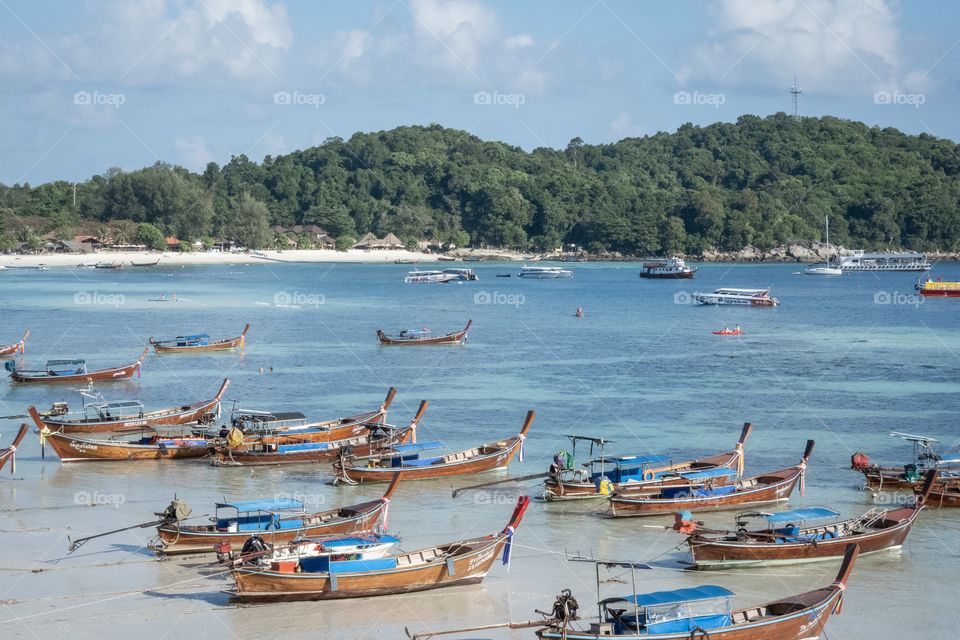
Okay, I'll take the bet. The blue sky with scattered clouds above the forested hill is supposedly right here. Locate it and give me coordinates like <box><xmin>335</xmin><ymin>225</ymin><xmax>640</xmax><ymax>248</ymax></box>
<box><xmin>0</xmin><ymin>0</ymin><xmax>960</xmax><ymax>184</ymax></box>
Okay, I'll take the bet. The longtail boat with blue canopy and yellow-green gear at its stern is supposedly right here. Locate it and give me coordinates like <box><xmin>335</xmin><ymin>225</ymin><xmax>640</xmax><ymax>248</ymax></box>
<box><xmin>543</xmin><ymin>422</ymin><xmax>753</xmax><ymax>501</ymax></box>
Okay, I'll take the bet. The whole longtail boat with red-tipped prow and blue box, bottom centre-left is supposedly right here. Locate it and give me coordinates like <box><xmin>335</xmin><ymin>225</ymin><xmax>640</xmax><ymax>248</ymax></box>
<box><xmin>232</xmin><ymin>496</ymin><xmax>530</xmax><ymax>602</ymax></box>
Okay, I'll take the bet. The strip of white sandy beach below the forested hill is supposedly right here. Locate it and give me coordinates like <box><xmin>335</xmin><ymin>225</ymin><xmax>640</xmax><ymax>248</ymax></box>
<box><xmin>0</xmin><ymin>249</ymin><xmax>446</xmax><ymax>268</ymax></box>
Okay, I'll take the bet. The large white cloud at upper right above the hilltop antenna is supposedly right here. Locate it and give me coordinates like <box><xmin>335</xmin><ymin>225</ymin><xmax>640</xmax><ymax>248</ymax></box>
<box><xmin>677</xmin><ymin>0</ymin><xmax>919</xmax><ymax>94</ymax></box>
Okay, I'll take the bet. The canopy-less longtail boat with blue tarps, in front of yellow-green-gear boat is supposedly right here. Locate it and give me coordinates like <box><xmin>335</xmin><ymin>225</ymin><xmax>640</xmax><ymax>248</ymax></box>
<box><xmin>610</xmin><ymin>440</ymin><xmax>813</xmax><ymax>517</ymax></box>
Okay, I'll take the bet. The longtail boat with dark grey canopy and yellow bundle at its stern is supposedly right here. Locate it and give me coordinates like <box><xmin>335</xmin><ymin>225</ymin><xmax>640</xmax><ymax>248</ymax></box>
<box><xmin>207</xmin><ymin>387</ymin><xmax>397</xmax><ymax>447</ymax></box>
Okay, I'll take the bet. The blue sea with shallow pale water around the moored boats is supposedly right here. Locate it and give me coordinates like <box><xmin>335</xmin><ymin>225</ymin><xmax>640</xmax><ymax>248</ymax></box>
<box><xmin>0</xmin><ymin>262</ymin><xmax>960</xmax><ymax>640</ymax></box>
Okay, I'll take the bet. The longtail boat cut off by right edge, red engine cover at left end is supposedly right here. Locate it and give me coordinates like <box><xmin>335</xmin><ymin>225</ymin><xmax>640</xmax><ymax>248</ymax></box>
<box><xmin>850</xmin><ymin>431</ymin><xmax>960</xmax><ymax>491</ymax></box>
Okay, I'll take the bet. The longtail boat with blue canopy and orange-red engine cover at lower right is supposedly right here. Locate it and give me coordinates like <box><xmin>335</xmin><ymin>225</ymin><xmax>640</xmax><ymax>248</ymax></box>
<box><xmin>674</xmin><ymin>470</ymin><xmax>937</xmax><ymax>569</ymax></box>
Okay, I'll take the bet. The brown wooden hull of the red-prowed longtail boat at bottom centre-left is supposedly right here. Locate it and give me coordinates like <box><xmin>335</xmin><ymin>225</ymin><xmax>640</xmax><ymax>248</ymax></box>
<box><xmin>232</xmin><ymin>534</ymin><xmax>507</xmax><ymax>602</ymax></box>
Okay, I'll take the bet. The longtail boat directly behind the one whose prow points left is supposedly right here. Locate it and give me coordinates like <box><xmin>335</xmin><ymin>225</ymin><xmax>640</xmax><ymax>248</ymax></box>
<box><xmin>27</xmin><ymin>379</ymin><xmax>230</xmax><ymax>433</ymax></box>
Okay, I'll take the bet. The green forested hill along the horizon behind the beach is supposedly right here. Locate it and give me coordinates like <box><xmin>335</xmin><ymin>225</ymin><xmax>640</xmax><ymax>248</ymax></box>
<box><xmin>0</xmin><ymin>113</ymin><xmax>960</xmax><ymax>255</ymax></box>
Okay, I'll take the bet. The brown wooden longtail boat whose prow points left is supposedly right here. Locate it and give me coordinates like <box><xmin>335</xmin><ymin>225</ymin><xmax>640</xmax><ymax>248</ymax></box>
<box><xmin>40</xmin><ymin>426</ymin><xmax>212</xmax><ymax>462</ymax></box>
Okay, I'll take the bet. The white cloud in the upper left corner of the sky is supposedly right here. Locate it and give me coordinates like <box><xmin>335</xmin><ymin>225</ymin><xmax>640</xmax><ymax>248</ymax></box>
<box><xmin>0</xmin><ymin>0</ymin><xmax>293</xmax><ymax>86</ymax></box>
